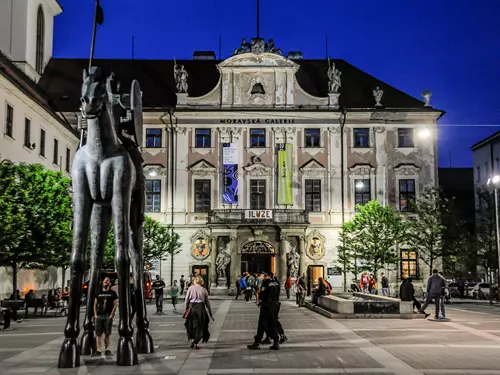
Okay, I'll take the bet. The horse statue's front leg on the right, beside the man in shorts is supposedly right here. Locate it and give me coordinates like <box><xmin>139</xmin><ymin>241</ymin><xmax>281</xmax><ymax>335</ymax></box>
<box><xmin>111</xmin><ymin>186</ymin><xmax>139</xmax><ymax>366</ymax></box>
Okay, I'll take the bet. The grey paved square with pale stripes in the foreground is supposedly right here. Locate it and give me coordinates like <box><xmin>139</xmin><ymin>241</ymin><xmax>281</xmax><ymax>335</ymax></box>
<box><xmin>0</xmin><ymin>299</ymin><xmax>500</xmax><ymax>375</ymax></box>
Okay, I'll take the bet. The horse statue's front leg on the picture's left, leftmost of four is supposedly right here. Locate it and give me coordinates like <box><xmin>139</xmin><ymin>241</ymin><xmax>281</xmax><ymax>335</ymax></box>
<box><xmin>58</xmin><ymin>177</ymin><xmax>92</xmax><ymax>368</ymax></box>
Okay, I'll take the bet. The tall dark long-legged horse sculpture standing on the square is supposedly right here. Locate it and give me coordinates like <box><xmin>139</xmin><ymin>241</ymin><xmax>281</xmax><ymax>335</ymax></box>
<box><xmin>59</xmin><ymin>67</ymin><xmax>154</xmax><ymax>368</ymax></box>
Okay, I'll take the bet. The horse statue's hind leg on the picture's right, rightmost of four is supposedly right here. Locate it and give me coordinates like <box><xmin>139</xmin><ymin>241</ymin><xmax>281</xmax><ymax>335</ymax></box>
<box><xmin>129</xmin><ymin>191</ymin><xmax>154</xmax><ymax>354</ymax></box>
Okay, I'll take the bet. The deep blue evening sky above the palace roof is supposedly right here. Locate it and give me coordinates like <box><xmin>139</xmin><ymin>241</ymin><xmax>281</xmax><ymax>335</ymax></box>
<box><xmin>54</xmin><ymin>0</ymin><xmax>500</xmax><ymax>167</ymax></box>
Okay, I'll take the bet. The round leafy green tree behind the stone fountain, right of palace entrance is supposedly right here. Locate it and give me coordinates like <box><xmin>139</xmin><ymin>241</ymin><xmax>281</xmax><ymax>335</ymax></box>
<box><xmin>339</xmin><ymin>201</ymin><xmax>407</xmax><ymax>280</ymax></box>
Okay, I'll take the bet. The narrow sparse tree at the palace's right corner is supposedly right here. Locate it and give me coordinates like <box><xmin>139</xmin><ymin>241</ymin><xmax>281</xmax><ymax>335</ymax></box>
<box><xmin>408</xmin><ymin>187</ymin><xmax>451</xmax><ymax>274</ymax></box>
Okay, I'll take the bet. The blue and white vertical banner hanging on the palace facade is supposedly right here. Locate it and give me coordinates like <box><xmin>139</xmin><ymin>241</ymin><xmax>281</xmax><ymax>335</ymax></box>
<box><xmin>222</xmin><ymin>143</ymin><xmax>238</xmax><ymax>204</ymax></box>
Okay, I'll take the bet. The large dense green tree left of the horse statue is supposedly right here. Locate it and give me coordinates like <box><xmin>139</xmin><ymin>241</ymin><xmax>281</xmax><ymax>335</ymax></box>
<box><xmin>0</xmin><ymin>160</ymin><xmax>71</xmax><ymax>291</ymax></box>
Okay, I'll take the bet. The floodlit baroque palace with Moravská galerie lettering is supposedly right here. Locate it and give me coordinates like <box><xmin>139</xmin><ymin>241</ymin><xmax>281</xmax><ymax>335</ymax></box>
<box><xmin>41</xmin><ymin>39</ymin><xmax>443</xmax><ymax>293</ymax></box>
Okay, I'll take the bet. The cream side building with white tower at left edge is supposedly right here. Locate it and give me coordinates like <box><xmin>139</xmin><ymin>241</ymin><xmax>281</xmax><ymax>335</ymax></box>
<box><xmin>0</xmin><ymin>0</ymin><xmax>79</xmax><ymax>298</ymax></box>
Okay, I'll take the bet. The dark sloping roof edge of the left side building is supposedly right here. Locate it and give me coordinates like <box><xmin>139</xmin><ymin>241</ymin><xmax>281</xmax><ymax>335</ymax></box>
<box><xmin>0</xmin><ymin>51</ymin><xmax>79</xmax><ymax>137</ymax></box>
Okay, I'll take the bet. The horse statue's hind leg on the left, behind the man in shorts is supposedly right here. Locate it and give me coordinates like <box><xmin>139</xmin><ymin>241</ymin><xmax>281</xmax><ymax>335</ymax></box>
<box><xmin>80</xmin><ymin>204</ymin><xmax>111</xmax><ymax>355</ymax></box>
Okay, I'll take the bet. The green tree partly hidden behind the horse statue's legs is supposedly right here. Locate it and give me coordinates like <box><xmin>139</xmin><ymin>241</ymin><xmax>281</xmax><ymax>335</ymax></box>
<box><xmin>102</xmin><ymin>216</ymin><xmax>182</xmax><ymax>269</ymax></box>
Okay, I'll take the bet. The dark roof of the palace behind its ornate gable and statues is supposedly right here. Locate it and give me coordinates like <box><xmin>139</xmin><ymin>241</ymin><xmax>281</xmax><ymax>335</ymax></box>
<box><xmin>40</xmin><ymin>58</ymin><xmax>442</xmax><ymax>112</ymax></box>
